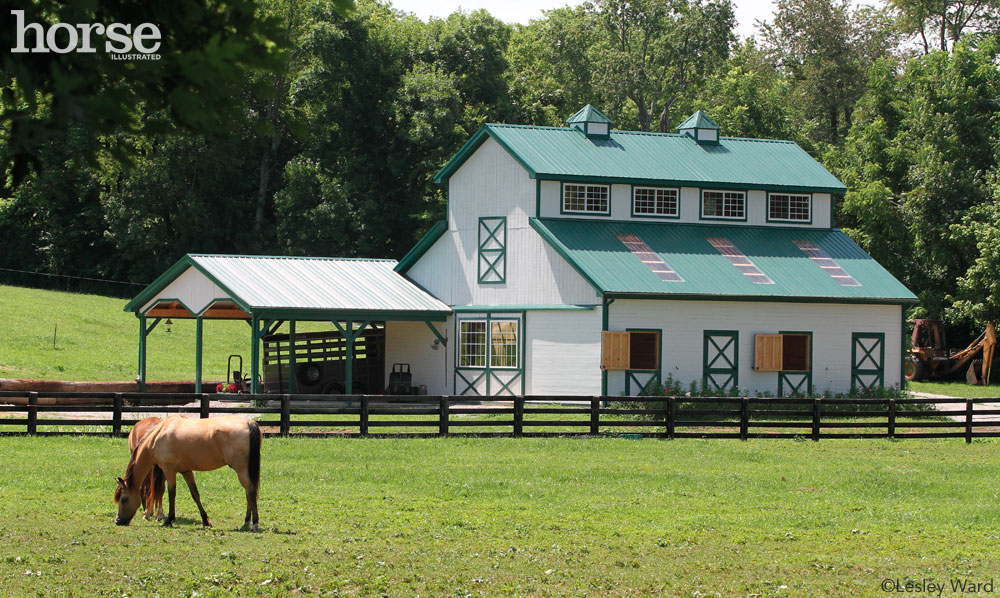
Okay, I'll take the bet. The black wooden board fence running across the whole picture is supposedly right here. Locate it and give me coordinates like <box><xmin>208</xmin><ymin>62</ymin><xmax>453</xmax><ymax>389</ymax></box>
<box><xmin>0</xmin><ymin>391</ymin><xmax>1000</xmax><ymax>442</ymax></box>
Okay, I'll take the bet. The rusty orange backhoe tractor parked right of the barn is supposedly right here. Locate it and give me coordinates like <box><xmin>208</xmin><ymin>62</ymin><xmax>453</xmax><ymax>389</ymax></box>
<box><xmin>906</xmin><ymin>318</ymin><xmax>997</xmax><ymax>386</ymax></box>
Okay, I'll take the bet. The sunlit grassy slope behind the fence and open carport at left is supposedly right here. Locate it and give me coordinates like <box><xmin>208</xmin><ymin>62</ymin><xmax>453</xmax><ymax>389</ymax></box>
<box><xmin>0</xmin><ymin>285</ymin><xmax>330</xmax><ymax>381</ymax></box>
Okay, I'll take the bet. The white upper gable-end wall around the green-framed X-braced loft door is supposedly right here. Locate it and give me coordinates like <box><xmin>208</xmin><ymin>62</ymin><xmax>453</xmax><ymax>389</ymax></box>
<box><xmin>407</xmin><ymin>139</ymin><xmax>599</xmax><ymax>305</ymax></box>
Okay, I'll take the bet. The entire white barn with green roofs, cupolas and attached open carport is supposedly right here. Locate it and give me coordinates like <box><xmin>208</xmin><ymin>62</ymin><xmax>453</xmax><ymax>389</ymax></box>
<box><xmin>126</xmin><ymin>105</ymin><xmax>917</xmax><ymax>396</ymax></box>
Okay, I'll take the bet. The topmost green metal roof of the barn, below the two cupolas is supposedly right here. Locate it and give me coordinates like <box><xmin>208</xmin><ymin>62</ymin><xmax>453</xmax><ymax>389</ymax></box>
<box><xmin>434</xmin><ymin>124</ymin><xmax>847</xmax><ymax>193</ymax></box>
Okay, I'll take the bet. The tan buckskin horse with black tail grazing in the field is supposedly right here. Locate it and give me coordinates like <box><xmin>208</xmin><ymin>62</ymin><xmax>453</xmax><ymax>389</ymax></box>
<box><xmin>115</xmin><ymin>415</ymin><xmax>261</xmax><ymax>532</ymax></box>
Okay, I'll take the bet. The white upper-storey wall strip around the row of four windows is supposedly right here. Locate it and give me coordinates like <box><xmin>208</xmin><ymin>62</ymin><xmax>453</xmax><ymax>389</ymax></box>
<box><xmin>540</xmin><ymin>181</ymin><xmax>830</xmax><ymax>228</ymax></box>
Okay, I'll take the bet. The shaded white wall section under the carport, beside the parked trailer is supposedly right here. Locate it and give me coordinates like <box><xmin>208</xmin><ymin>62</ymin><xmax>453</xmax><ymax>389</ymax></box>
<box><xmin>385</xmin><ymin>318</ymin><xmax>454</xmax><ymax>395</ymax></box>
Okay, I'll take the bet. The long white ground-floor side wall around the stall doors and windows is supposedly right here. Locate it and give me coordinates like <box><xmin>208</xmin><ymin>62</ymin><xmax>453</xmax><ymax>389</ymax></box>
<box><xmin>608</xmin><ymin>299</ymin><xmax>902</xmax><ymax>395</ymax></box>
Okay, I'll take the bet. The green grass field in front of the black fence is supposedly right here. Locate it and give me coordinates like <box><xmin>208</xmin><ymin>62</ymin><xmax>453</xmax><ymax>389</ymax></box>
<box><xmin>0</xmin><ymin>437</ymin><xmax>1000</xmax><ymax>597</ymax></box>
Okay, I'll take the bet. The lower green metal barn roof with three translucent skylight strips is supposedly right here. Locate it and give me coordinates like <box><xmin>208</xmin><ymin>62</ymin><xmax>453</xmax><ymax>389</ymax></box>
<box><xmin>531</xmin><ymin>218</ymin><xmax>917</xmax><ymax>304</ymax></box>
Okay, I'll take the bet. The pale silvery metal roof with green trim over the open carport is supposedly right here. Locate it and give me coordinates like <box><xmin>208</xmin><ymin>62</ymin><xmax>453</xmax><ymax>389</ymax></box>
<box><xmin>125</xmin><ymin>254</ymin><xmax>451</xmax><ymax>316</ymax></box>
